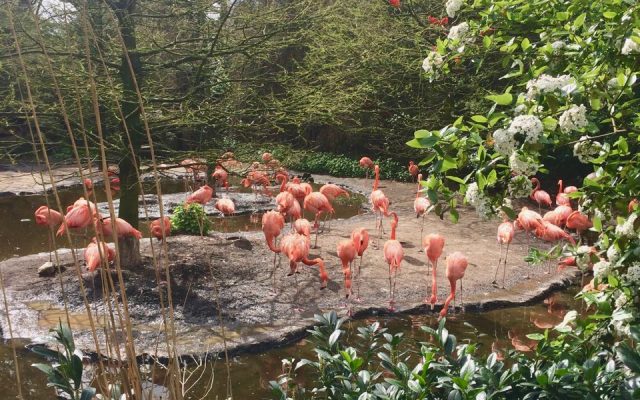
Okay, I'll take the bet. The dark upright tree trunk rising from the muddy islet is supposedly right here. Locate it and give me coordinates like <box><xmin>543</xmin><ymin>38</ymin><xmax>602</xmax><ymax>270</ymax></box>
<box><xmin>109</xmin><ymin>0</ymin><xmax>145</xmax><ymax>267</ymax></box>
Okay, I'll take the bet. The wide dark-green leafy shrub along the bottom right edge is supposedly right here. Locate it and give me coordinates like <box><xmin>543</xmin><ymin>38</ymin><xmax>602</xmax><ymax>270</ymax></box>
<box><xmin>270</xmin><ymin>312</ymin><xmax>640</xmax><ymax>400</ymax></box>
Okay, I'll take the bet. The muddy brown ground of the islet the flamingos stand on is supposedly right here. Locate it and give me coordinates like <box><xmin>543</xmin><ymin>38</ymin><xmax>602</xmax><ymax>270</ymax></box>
<box><xmin>0</xmin><ymin>175</ymin><xmax>576</xmax><ymax>356</ymax></box>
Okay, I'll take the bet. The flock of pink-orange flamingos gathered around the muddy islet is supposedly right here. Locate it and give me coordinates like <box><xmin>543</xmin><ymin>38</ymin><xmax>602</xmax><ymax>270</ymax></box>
<box><xmin>35</xmin><ymin>153</ymin><xmax>592</xmax><ymax>316</ymax></box>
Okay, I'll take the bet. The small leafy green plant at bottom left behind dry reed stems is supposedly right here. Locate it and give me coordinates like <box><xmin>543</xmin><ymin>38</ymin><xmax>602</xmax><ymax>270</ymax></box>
<box><xmin>32</xmin><ymin>322</ymin><xmax>96</xmax><ymax>400</ymax></box>
